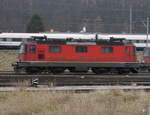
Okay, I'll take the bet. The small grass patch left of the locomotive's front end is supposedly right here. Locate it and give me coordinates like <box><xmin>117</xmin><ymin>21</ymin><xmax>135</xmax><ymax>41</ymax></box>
<box><xmin>0</xmin><ymin>50</ymin><xmax>18</xmax><ymax>71</ymax></box>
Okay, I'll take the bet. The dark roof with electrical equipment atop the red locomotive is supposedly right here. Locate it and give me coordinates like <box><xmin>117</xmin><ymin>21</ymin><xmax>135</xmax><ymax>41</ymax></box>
<box><xmin>26</xmin><ymin>36</ymin><xmax>132</xmax><ymax>45</ymax></box>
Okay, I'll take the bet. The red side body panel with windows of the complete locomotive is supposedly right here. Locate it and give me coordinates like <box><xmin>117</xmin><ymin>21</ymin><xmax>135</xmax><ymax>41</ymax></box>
<box><xmin>20</xmin><ymin>43</ymin><xmax>136</xmax><ymax>62</ymax></box>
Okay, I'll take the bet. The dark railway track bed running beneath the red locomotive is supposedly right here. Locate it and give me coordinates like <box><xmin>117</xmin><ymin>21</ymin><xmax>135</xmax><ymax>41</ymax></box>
<box><xmin>0</xmin><ymin>72</ymin><xmax>150</xmax><ymax>86</ymax></box>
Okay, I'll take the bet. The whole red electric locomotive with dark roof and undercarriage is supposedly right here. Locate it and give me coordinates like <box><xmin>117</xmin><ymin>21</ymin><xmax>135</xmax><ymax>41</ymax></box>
<box><xmin>13</xmin><ymin>37</ymin><xmax>139</xmax><ymax>74</ymax></box>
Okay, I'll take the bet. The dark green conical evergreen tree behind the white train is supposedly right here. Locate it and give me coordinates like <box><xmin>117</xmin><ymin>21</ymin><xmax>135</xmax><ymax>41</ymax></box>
<box><xmin>26</xmin><ymin>14</ymin><xmax>44</xmax><ymax>33</ymax></box>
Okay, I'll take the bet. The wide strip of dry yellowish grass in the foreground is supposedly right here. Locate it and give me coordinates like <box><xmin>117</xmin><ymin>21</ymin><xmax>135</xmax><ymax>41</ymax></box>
<box><xmin>0</xmin><ymin>90</ymin><xmax>150</xmax><ymax>115</ymax></box>
